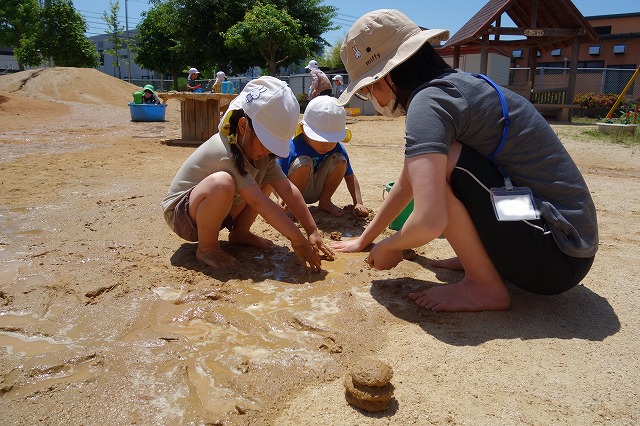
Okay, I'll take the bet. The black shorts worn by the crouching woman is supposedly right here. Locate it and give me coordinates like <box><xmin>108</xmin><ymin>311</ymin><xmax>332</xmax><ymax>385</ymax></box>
<box><xmin>451</xmin><ymin>145</ymin><xmax>594</xmax><ymax>294</ymax></box>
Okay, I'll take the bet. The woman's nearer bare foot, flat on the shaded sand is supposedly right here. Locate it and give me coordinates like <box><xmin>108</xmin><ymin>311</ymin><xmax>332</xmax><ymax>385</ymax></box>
<box><xmin>409</xmin><ymin>277</ymin><xmax>511</xmax><ymax>312</ymax></box>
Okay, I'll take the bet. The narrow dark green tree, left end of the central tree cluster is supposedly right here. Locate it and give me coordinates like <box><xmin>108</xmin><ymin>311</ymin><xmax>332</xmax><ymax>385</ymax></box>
<box><xmin>134</xmin><ymin>0</ymin><xmax>189</xmax><ymax>90</ymax></box>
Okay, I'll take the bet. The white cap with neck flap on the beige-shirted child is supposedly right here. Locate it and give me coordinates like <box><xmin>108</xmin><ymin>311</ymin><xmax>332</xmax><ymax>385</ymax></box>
<box><xmin>218</xmin><ymin>76</ymin><xmax>300</xmax><ymax>157</ymax></box>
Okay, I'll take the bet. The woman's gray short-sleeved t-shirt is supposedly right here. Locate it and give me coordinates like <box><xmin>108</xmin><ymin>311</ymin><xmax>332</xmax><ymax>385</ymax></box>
<box><xmin>405</xmin><ymin>71</ymin><xmax>598</xmax><ymax>258</ymax></box>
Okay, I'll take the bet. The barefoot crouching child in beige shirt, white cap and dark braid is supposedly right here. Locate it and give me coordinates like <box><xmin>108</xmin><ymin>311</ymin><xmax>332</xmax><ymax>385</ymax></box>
<box><xmin>162</xmin><ymin>77</ymin><xmax>332</xmax><ymax>271</ymax></box>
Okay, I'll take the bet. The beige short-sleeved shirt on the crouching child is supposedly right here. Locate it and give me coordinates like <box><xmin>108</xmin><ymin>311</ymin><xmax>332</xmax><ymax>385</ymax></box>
<box><xmin>161</xmin><ymin>133</ymin><xmax>287</xmax><ymax>230</ymax></box>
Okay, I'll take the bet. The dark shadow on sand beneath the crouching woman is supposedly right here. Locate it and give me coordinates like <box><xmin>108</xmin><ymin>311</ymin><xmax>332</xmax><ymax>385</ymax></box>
<box><xmin>371</xmin><ymin>271</ymin><xmax>620</xmax><ymax>346</ymax></box>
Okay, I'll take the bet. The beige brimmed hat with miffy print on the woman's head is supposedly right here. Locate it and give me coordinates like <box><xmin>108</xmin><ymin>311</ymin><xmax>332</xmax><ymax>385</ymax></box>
<box><xmin>338</xmin><ymin>9</ymin><xmax>449</xmax><ymax>105</ymax></box>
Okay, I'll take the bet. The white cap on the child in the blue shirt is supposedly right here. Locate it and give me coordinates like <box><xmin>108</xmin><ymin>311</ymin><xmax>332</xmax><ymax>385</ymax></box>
<box><xmin>302</xmin><ymin>96</ymin><xmax>347</xmax><ymax>143</ymax></box>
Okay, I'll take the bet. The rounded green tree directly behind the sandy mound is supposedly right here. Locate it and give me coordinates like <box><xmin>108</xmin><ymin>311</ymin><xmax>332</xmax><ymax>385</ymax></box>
<box><xmin>14</xmin><ymin>0</ymin><xmax>100</xmax><ymax>67</ymax></box>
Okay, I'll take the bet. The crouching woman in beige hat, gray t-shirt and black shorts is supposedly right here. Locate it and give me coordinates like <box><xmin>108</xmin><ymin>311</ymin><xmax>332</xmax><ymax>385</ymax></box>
<box><xmin>333</xmin><ymin>9</ymin><xmax>598</xmax><ymax>311</ymax></box>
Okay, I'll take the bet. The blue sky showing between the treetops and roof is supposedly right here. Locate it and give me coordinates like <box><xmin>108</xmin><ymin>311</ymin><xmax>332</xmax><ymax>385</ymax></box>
<box><xmin>73</xmin><ymin>0</ymin><xmax>640</xmax><ymax>45</ymax></box>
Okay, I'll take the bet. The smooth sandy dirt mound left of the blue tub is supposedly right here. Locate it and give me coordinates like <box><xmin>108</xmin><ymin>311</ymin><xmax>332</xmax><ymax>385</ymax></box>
<box><xmin>0</xmin><ymin>67</ymin><xmax>140</xmax><ymax>106</ymax></box>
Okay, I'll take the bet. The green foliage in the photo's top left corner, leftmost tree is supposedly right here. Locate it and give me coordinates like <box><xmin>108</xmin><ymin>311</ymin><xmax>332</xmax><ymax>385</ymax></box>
<box><xmin>0</xmin><ymin>0</ymin><xmax>40</xmax><ymax>47</ymax></box>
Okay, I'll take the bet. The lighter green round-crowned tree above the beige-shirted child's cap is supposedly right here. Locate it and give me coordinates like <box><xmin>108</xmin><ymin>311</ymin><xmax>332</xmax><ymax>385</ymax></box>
<box><xmin>224</xmin><ymin>3</ymin><xmax>314</xmax><ymax>76</ymax></box>
